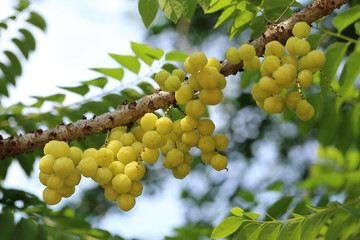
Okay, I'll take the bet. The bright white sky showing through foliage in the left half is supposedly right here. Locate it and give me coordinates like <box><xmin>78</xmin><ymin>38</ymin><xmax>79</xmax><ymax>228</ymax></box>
<box><xmin>0</xmin><ymin>0</ymin><xmax>184</xmax><ymax>239</ymax></box>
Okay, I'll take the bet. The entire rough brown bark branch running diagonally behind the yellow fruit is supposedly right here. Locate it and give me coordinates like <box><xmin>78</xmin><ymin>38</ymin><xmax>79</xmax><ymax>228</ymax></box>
<box><xmin>0</xmin><ymin>0</ymin><xmax>349</xmax><ymax>159</ymax></box>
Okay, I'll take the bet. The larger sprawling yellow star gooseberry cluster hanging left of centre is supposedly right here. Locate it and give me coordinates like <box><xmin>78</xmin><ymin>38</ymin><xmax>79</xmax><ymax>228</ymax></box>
<box><xmin>39</xmin><ymin>53</ymin><xmax>229</xmax><ymax>211</ymax></box>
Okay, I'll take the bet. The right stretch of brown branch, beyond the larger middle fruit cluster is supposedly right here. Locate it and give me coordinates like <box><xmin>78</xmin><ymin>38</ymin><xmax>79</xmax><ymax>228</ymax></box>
<box><xmin>221</xmin><ymin>0</ymin><xmax>349</xmax><ymax>76</ymax></box>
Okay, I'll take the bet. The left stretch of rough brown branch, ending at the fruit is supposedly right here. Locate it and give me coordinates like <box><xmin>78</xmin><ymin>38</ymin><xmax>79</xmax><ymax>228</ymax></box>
<box><xmin>0</xmin><ymin>91</ymin><xmax>175</xmax><ymax>159</ymax></box>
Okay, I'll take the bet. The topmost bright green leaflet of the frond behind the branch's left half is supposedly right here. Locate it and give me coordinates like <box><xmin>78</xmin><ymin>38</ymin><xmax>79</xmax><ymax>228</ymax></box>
<box><xmin>131</xmin><ymin>42</ymin><xmax>164</xmax><ymax>66</ymax></box>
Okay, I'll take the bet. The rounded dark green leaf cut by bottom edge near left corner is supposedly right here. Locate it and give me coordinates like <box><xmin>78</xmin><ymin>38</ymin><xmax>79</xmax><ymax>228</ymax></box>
<box><xmin>10</xmin><ymin>218</ymin><xmax>37</xmax><ymax>240</ymax></box>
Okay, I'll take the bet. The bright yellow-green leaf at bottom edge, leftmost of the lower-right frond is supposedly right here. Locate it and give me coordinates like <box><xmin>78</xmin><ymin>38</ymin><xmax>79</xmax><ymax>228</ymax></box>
<box><xmin>210</xmin><ymin>216</ymin><xmax>244</xmax><ymax>239</ymax></box>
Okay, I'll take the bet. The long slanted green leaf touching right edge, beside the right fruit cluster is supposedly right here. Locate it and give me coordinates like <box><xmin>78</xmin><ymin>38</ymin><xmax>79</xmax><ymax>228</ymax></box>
<box><xmin>339</xmin><ymin>51</ymin><xmax>360</xmax><ymax>96</ymax></box>
